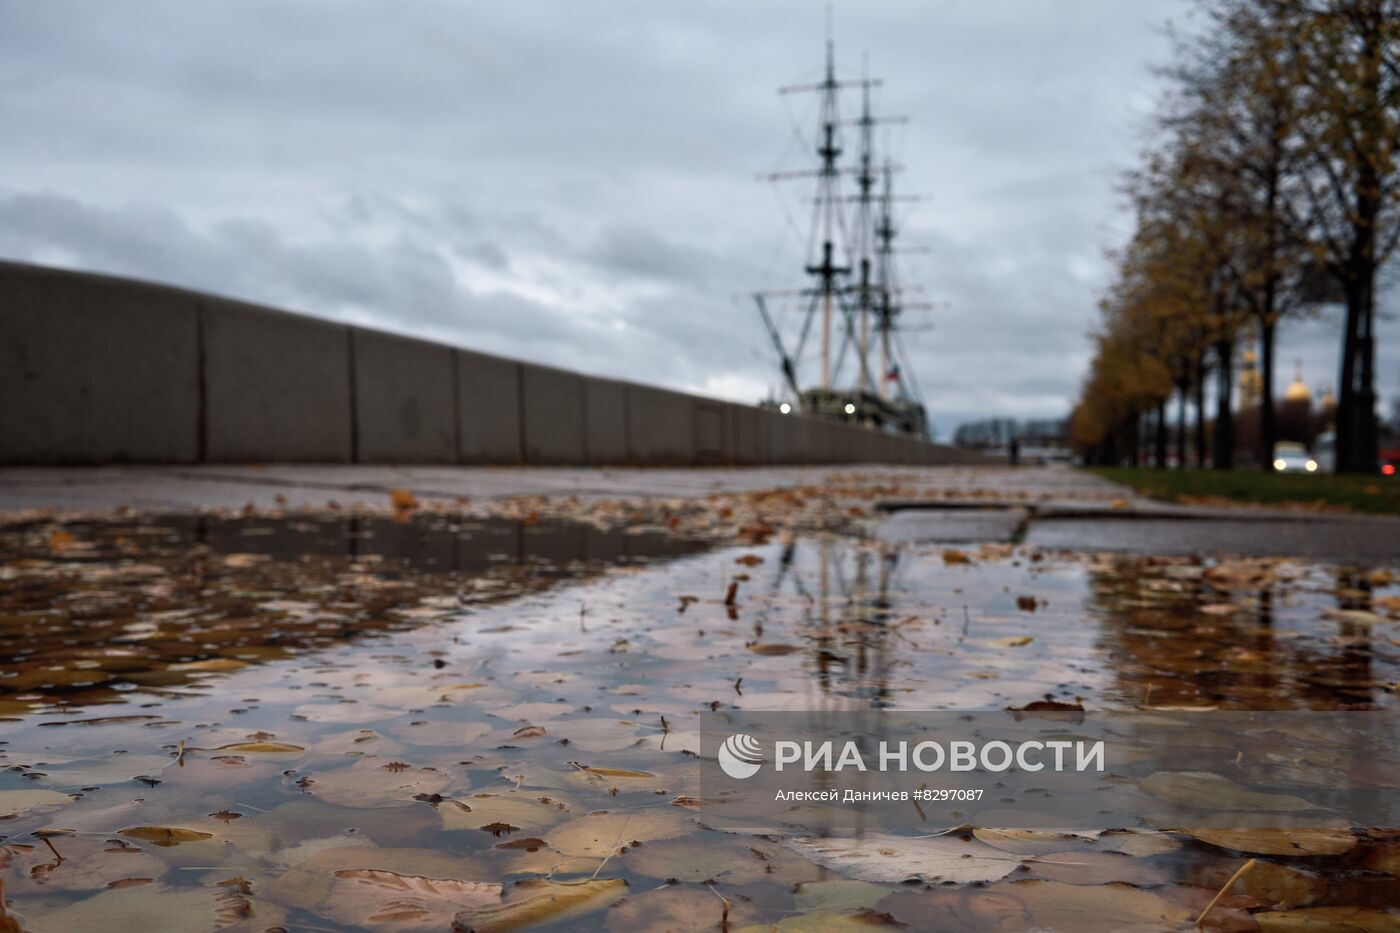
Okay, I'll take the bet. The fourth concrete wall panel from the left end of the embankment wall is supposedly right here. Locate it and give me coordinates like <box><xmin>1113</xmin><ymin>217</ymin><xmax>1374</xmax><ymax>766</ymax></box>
<box><xmin>456</xmin><ymin>350</ymin><xmax>524</xmax><ymax>464</ymax></box>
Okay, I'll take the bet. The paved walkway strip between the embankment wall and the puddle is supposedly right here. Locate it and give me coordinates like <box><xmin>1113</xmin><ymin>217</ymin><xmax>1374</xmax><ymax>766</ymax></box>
<box><xmin>0</xmin><ymin>465</ymin><xmax>1400</xmax><ymax>563</ymax></box>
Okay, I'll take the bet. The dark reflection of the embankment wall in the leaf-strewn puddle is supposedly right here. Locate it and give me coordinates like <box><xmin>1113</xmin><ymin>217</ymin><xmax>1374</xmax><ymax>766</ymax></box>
<box><xmin>0</xmin><ymin>514</ymin><xmax>706</xmax><ymax>712</ymax></box>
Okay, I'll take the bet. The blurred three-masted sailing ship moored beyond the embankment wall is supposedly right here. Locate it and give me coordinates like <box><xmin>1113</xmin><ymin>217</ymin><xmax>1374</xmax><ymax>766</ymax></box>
<box><xmin>753</xmin><ymin>29</ymin><xmax>930</xmax><ymax>438</ymax></box>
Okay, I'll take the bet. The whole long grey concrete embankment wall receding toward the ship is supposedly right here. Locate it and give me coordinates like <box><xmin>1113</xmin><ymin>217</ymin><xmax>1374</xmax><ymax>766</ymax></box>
<box><xmin>0</xmin><ymin>262</ymin><xmax>981</xmax><ymax>465</ymax></box>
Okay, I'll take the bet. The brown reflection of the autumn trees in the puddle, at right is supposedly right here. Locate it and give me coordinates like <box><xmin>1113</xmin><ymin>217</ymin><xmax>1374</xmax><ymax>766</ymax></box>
<box><xmin>1086</xmin><ymin>558</ymin><xmax>1400</xmax><ymax>709</ymax></box>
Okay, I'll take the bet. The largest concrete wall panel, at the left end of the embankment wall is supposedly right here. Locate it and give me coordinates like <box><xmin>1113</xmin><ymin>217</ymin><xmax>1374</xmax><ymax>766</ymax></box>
<box><xmin>0</xmin><ymin>263</ymin><xmax>200</xmax><ymax>464</ymax></box>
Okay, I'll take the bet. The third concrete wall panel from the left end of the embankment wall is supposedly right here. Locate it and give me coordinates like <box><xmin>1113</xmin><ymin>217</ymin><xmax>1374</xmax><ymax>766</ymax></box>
<box><xmin>351</xmin><ymin>328</ymin><xmax>458</xmax><ymax>464</ymax></box>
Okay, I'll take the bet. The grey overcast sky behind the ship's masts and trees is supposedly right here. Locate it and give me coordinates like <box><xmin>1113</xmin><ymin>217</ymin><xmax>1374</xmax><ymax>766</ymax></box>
<box><xmin>0</xmin><ymin>0</ymin><xmax>1400</xmax><ymax>437</ymax></box>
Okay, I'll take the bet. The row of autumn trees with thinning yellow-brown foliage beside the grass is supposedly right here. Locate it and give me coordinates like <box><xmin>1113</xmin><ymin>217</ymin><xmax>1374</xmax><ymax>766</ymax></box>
<box><xmin>1074</xmin><ymin>0</ymin><xmax>1400</xmax><ymax>471</ymax></box>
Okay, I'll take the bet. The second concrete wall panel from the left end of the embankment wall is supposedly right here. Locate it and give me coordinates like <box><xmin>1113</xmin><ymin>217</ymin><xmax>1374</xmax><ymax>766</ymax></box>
<box><xmin>200</xmin><ymin>297</ymin><xmax>354</xmax><ymax>464</ymax></box>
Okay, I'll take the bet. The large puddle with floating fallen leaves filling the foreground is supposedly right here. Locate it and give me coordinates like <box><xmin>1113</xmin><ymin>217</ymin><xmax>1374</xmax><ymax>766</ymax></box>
<box><xmin>0</xmin><ymin>520</ymin><xmax>1400</xmax><ymax>933</ymax></box>
